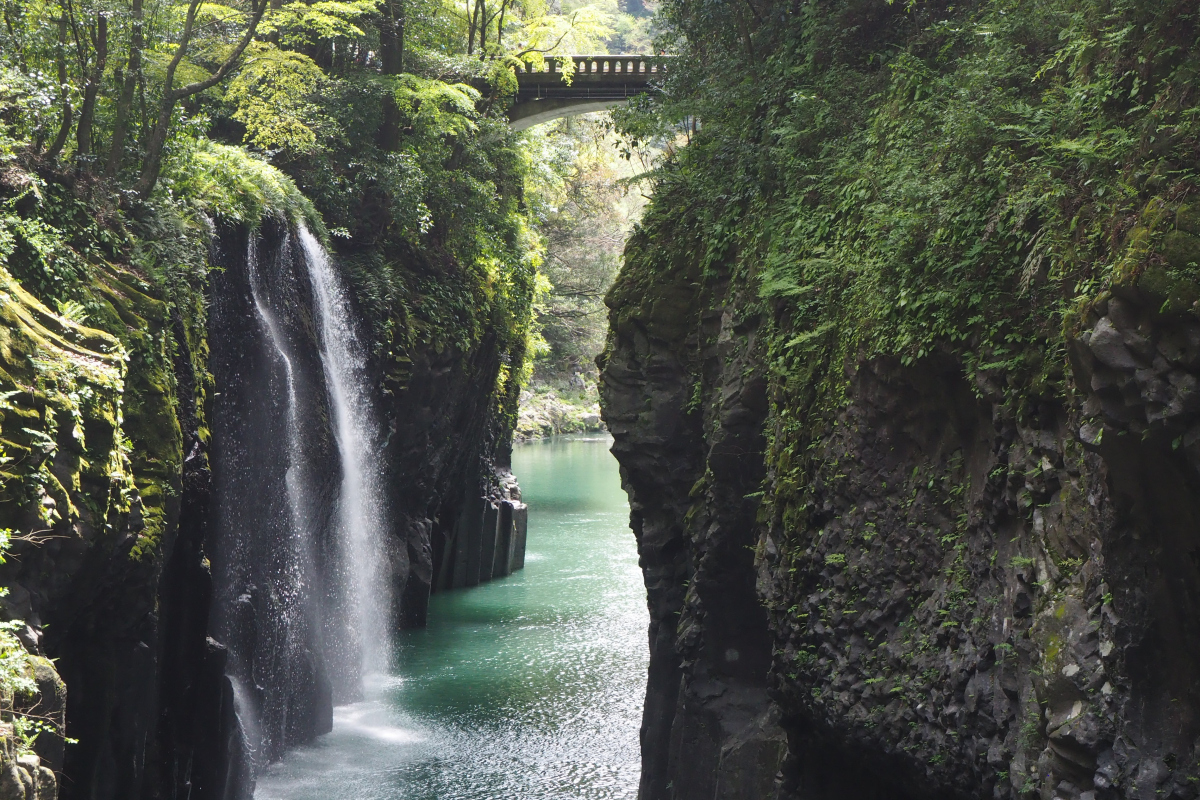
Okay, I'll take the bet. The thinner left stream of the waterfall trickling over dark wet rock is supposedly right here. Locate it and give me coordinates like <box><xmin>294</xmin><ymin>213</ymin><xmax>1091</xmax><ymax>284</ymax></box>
<box><xmin>212</xmin><ymin>234</ymin><xmax>330</xmax><ymax>760</ymax></box>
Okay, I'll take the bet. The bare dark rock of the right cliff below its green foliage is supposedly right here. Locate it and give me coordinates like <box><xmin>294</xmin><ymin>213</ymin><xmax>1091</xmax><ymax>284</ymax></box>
<box><xmin>601</xmin><ymin>217</ymin><xmax>1200</xmax><ymax>800</ymax></box>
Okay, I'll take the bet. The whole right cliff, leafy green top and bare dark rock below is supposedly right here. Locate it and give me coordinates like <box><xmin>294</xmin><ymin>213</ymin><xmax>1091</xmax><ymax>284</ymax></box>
<box><xmin>601</xmin><ymin>2</ymin><xmax>1200</xmax><ymax>800</ymax></box>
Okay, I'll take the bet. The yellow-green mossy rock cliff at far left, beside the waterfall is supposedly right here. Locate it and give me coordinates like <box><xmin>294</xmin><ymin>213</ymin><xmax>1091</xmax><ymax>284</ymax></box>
<box><xmin>0</xmin><ymin>242</ymin><xmax>181</xmax><ymax>798</ymax></box>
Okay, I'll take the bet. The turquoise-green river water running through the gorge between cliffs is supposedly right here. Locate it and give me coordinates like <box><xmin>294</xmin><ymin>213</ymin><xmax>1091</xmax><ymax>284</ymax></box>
<box><xmin>254</xmin><ymin>437</ymin><xmax>648</xmax><ymax>800</ymax></box>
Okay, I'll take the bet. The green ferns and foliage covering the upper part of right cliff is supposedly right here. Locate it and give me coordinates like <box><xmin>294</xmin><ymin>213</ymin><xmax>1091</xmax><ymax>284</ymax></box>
<box><xmin>613</xmin><ymin>0</ymin><xmax>1200</xmax><ymax>606</ymax></box>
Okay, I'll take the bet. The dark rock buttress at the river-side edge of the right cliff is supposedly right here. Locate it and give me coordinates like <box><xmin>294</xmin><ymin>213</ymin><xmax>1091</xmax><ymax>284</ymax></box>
<box><xmin>601</xmin><ymin>227</ymin><xmax>782</xmax><ymax>798</ymax></box>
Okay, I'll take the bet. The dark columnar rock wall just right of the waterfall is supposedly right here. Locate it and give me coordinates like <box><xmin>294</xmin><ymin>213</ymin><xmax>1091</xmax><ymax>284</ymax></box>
<box><xmin>333</xmin><ymin>254</ymin><xmax>526</xmax><ymax>627</ymax></box>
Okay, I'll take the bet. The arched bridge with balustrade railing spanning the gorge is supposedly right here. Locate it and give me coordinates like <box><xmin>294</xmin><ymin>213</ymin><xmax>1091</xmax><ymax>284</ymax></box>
<box><xmin>509</xmin><ymin>55</ymin><xmax>671</xmax><ymax>131</ymax></box>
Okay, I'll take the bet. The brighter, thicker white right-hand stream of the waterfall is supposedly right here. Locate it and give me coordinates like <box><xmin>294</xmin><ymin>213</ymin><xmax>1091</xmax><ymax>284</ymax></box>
<box><xmin>300</xmin><ymin>224</ymin><xmax>390</xmax><ymax>673</ymax></box>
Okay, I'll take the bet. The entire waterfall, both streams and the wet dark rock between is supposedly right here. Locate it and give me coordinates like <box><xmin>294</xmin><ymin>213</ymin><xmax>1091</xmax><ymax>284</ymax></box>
<box><xmin>210</xmin><ymin>220</ymin><xmax>390</xmax><ymax>798</ymax></box>
